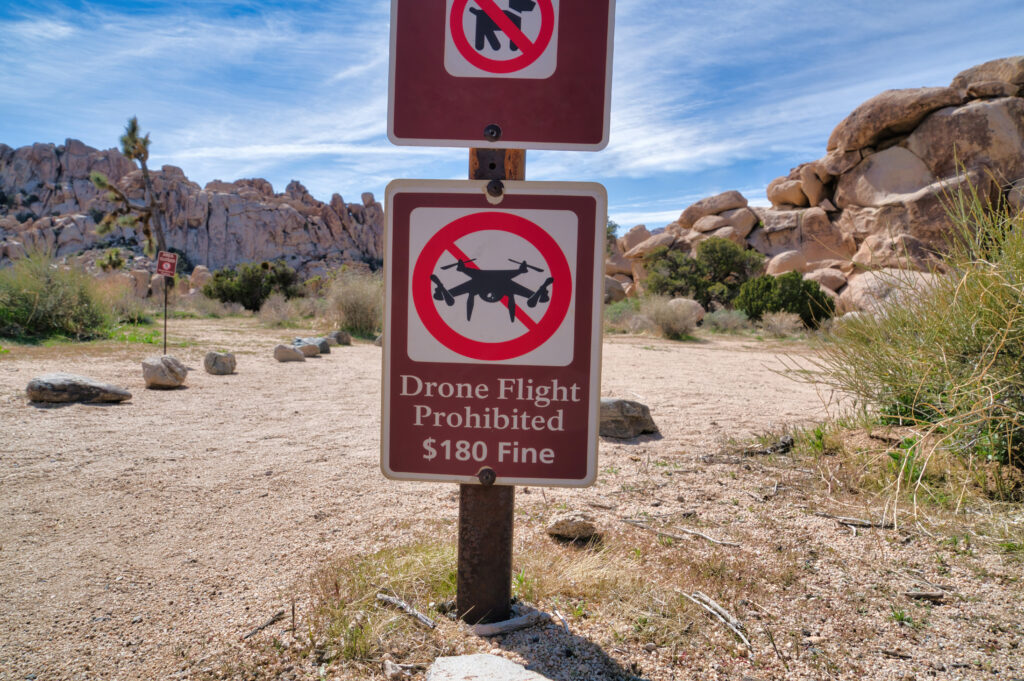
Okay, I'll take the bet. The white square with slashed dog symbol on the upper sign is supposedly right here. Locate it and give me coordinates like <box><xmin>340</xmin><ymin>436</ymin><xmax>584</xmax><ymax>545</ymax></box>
<box><xmin>444</xmin><ymin>0</ymin><xmax>559</xmax><ymax>79</ymax></box>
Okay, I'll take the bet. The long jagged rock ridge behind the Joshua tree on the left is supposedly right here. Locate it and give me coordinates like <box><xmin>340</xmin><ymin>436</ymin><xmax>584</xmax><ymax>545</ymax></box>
<box><xmin>0</xmin><ymin>139</ymin><xmax>384</xmax><ymax>278</ymax></box>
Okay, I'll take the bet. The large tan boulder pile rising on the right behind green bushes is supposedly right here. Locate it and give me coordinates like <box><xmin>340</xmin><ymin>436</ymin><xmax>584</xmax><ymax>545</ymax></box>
<box><xmin>605</xmin><ymin>56</ymin><xmax>1024</xmax><ymax>311</ymax></box>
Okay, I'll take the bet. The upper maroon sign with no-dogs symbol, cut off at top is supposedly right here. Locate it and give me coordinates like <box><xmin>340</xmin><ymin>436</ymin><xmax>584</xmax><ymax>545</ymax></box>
<box><xmin>388</xmin><ymin>0</ymin><xmax>615</xmax><ymax>151</ymax></box>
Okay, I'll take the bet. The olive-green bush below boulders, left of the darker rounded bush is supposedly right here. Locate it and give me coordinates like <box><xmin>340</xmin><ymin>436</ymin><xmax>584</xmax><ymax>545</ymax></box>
<box><xmin>644</xmin><ymin>237</ymin><xmax>764</xmax><ymax>308</ymax></box>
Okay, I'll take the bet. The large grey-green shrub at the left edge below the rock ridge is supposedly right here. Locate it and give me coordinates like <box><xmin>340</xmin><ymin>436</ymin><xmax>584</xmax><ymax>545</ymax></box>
<box><xmin>0</xmin><ymin>253</ymin><xmax>112</xmax><ymax>340</ymax></box>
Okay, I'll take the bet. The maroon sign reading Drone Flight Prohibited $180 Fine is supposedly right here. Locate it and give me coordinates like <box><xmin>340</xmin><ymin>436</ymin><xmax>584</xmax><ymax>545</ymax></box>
<box><xmin>381</xmin><ymin>180</ymin><xmax>607</xmax><ymax>486</ymax></box>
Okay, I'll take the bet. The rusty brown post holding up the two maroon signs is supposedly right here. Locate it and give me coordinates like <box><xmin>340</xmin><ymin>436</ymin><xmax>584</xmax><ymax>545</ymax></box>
<box><xmin>456</xmin><ymin>148</ymin><xmax>526</xmax><ymax>624</ymax></box>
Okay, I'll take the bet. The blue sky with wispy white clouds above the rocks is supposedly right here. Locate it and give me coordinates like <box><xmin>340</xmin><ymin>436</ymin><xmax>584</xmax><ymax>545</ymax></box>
<box><xmin>0</xmin><ymin>0</ymin><xmax>1024</xmax><ymax>227</ymax></box>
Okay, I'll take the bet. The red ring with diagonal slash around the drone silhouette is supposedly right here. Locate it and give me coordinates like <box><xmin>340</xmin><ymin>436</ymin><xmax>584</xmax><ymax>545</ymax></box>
<box><xmin>413</xmin><ymin>212</ymin><xmax>572</xmax><ymax>361</ymax></box>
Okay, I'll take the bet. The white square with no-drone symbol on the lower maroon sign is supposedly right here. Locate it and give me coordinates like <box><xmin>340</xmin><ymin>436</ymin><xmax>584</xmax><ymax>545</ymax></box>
<box><xmin>409</xmin><ymin>208</ymin><xmax>592</xmax><ymax>367</ymax></box>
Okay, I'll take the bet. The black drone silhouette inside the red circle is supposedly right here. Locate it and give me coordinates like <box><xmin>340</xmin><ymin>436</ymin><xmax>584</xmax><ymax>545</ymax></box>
<box><xmin>430</xmin><ymin>258</ymin><xmax>555</xmax><ymax>322</ymax></box>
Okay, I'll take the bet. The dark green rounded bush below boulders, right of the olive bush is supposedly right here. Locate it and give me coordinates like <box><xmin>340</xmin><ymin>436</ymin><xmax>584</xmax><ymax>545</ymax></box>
<box><xmin>734</xmin><ymin>271</ymin><xmax>836</xmax><ymax>329</ymax></box>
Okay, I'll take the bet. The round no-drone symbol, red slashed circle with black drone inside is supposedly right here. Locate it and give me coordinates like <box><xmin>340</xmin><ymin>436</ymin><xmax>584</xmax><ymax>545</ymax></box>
<box><xmin>412</xmin><ymin>212</ymin><xmax>572</xmax><ymax>361</ymax></box>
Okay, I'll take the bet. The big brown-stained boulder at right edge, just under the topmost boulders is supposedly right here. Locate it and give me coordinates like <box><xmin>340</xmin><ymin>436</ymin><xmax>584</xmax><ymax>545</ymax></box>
<box><xmin>906</xmin><ymin>97</ymin><xmax>1024</xmax><ymax>182</ymax></box>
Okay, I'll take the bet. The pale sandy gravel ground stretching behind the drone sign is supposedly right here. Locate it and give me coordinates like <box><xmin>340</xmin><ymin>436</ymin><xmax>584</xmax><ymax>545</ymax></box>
<box><xmin>0</xmin><ymin>320</ymin><xmax>1024</xmax><ymax>680</ymax></box>
